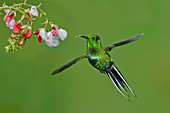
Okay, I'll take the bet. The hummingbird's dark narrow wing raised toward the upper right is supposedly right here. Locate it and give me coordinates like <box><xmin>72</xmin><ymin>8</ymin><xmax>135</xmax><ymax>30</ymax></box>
<box><xmin>104</xmin><ymin>33</ymin><xmax>144</xmax><ymax>51</ymax></box>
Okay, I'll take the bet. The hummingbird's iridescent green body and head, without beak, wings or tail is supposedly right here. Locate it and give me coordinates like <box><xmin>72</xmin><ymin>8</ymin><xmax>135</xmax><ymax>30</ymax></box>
<box><xmin>87</xmin><ymin>35</ymin><xmax>112</xmax><ymax>73</ymax></box>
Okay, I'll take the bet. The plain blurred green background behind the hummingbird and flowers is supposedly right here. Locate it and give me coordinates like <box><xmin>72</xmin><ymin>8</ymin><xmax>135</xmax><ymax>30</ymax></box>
<box><xmin>0</xmin><ymin>0</ymin><xmax>170</xmax><ymax>113</ymax></box>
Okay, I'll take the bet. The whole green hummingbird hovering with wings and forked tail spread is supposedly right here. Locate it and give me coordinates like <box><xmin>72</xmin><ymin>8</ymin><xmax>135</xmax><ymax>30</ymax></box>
<box><xmin>52</xmin><ymin>33</ymin><xmax>144</xmax><ymax>100</ymax></box>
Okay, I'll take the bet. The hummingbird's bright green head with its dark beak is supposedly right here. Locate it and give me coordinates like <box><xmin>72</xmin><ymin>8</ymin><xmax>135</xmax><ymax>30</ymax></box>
<box><xmin>80</xmin><ymin>34</ymin><xmax>101</xmax><ymax>48</ymax></box>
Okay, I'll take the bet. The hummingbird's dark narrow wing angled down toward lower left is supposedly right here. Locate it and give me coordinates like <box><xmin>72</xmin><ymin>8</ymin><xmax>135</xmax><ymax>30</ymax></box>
<box><xmin>51</xmin><ymin>55</ymin><xmax>87</xmax><ymax>75</ymax></box>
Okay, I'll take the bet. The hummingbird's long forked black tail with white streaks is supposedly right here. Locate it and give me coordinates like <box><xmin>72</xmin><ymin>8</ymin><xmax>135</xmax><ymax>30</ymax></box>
<box><xmin>107</xmin><ymin>65</ymin><xmax>136</xmax><ymax>100</ymax></box>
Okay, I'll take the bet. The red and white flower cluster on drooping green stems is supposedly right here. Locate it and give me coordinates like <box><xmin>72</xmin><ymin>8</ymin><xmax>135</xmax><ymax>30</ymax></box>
<box><xmin>0</xmin><ymin>0</ymin><xmax>67</xmax><ymax>52</ymax></box>
